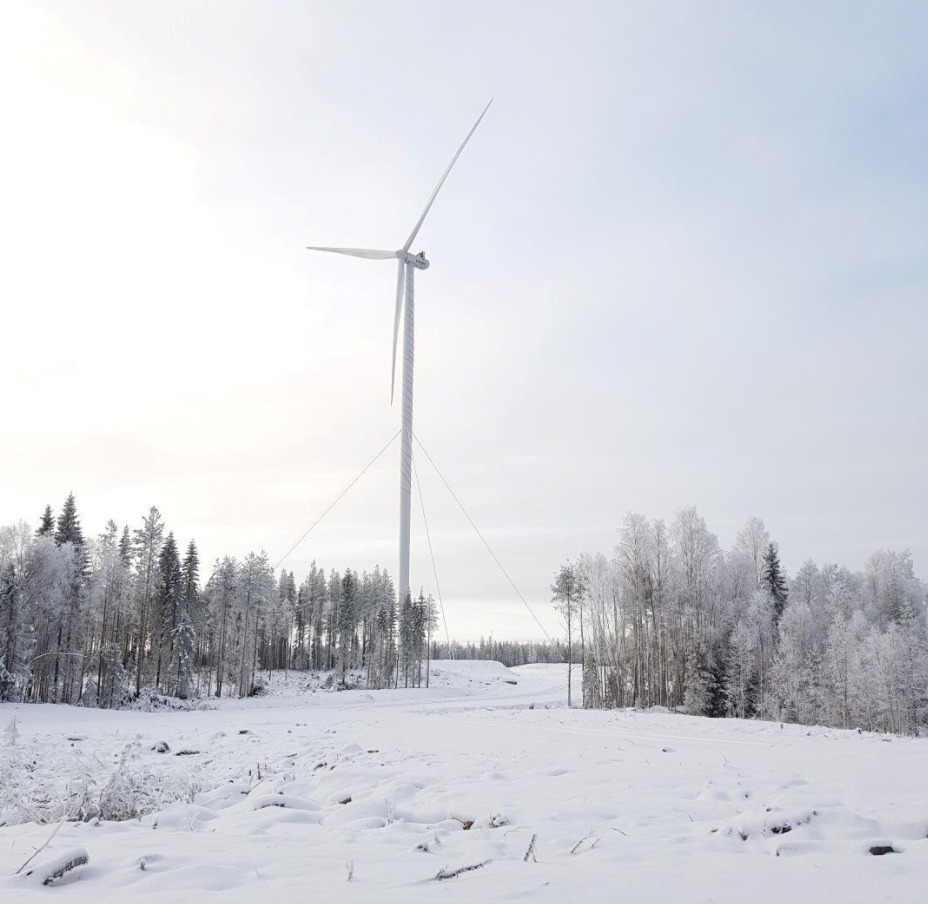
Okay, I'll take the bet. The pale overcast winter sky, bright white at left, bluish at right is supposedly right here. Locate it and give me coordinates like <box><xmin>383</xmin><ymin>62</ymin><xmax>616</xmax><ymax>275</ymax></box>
<box><xmin>0</xmin><ymin>0</ymin><xmax>928</xmax><ymax>638</ymax></box>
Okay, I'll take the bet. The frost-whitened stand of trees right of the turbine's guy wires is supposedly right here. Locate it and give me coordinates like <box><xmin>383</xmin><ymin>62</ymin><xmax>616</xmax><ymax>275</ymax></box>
<box><xmin>552</xmin><ymin>508</ymin><xmax>928</xmax><ymax>734</ymax></box>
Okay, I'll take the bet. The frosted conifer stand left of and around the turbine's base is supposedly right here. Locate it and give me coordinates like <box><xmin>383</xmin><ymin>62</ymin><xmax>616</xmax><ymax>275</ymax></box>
<box><xmin>0</xmin><ymin>494</ymin><xmax>436</xmax><ymax>708</ymax></box>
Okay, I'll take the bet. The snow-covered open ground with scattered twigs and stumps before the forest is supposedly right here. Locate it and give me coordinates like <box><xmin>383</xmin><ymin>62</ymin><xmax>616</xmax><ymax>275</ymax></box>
<box><xmin>0</xmin><ymin>662</ymin><xmax>928</xmax><ymax>904</ymax></box>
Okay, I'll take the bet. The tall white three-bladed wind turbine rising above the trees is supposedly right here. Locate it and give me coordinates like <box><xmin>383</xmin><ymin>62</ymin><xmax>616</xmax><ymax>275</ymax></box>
<box><xmin>307</xmin><ymin>98</ymin><xmax>493</xmax><ymax>605</ymax></box>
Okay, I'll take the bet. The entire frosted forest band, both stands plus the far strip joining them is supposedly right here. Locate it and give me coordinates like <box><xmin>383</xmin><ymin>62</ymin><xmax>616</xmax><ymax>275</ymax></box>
<box><xmin>0</xmin><ymin>495</ymin><xmax>928</xmax><ymax>734</ymax></box>
